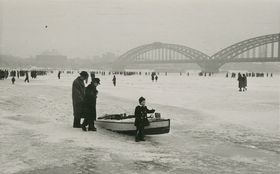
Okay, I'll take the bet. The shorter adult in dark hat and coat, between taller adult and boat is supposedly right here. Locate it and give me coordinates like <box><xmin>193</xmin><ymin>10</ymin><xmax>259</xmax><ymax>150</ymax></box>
<box><xmin>82</xmin><ymin>78</ymin><xmax>100</xmax><ymax>131</ymax></box>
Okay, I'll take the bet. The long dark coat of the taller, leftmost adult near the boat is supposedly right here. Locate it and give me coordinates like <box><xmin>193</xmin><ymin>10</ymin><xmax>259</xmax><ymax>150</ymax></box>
<box><xmin>72</xmin><ymin>77</ymin><xmax>85</xmax><ymax>118</ymax></box>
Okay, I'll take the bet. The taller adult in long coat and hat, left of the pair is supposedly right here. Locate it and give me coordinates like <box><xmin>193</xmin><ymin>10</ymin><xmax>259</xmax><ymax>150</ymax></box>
<box><xmin>72</xmin><ymin>71</ymin><xmax>88</xmax><ymax>128</ymax></box>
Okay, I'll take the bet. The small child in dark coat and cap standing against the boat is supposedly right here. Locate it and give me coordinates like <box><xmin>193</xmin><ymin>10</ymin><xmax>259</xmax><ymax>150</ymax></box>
<box><xmin>134</xmin><ymin>97</ymin><xmax>155</xmax><ymax>142</ymax></box>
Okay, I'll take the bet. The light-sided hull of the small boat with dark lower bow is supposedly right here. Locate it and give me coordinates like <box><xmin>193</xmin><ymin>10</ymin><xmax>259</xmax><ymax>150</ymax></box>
<box><xmin>96</xmin><ymin>119</ymin><xmax>170</xmax><ymax>135</ymax></box>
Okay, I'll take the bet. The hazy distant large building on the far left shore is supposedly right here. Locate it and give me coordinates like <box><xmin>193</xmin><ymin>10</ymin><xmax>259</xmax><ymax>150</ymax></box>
<box><xmin>35</xmin><ymin>50</ymin><xmax>67</xmax><ymax>68</ymax></box>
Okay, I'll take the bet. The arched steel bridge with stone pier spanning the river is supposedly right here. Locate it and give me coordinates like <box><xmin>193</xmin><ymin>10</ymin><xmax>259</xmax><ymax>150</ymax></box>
<box><xmin>113</xmin><ymin>33</ymin><xmax>280</xmax><ymax>72</ymax></box>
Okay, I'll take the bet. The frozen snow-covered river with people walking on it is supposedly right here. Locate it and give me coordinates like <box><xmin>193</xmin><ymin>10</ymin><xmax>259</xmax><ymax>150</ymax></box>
<box><xmin>0</xmin><ymin>74</ymin><xmax>280</xmax><ymax>174</ymax></box>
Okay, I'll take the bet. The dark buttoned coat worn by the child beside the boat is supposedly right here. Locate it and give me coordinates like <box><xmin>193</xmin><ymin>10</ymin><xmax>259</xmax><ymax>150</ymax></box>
<box><xmin>134</xmin><ymin>106</ymin><xmax>155</xmax><ymax>126</ymax></box>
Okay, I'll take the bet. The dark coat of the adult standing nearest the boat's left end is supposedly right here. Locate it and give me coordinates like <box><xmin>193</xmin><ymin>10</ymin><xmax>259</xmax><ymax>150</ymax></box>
<box><xmin>84</xmin><ymin>83</ymin><xmax>98</xmax><ymax>120</ymax></box>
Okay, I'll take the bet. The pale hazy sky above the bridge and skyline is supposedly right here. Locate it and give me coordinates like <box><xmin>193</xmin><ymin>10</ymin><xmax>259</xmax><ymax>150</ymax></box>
<box><xmin>0</xmin><ymin>0</ymin><xmax>280</xmax><ymax>57</ymax></box>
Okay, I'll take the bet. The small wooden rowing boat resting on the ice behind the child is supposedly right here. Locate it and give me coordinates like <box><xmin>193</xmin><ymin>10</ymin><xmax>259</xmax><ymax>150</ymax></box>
<box><xmin>95</xmin><ymin>113</ymin><xmax>170</xmax><ymax>135</ymax></box>
